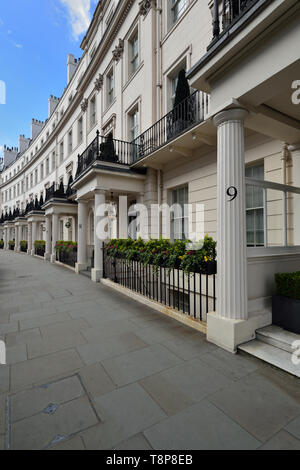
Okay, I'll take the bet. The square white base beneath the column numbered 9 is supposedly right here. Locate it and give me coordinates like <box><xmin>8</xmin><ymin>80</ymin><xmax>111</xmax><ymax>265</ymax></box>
<box><xmin>207</xmin><ymin>311</ymin><xmax>272</xmax><ymax>353</ymax></box>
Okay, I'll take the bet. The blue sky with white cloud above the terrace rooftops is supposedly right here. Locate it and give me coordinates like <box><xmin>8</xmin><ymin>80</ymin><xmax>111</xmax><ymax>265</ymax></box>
<box><xmin>0</xmin><ymin>0</ymin><xmax>97</xmax><ymax>156</ymax></box>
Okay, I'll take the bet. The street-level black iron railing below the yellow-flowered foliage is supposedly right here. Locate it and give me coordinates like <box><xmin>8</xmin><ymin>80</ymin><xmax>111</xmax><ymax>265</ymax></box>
<box><xmin>103</xmin><ymin>250</ymin><xmax>216</xmax><ymax>321</ymax></box>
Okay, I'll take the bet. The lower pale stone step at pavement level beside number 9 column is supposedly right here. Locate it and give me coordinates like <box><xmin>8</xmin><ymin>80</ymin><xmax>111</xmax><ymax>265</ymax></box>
<box><xmin>238</xmin><ymin>339</ymin><xmax>300</xmax><ymax>378</ymax></box>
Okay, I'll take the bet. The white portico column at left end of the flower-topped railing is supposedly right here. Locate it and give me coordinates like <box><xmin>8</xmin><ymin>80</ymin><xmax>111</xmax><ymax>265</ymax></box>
<box><xmin>91</xmin><ymin>190</ymin><xmax>105</xmax><ymax>282</ymax></box>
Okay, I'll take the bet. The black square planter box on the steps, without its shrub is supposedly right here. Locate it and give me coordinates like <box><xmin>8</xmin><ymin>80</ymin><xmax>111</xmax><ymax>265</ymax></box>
<box><xmin>272</xmin><ymin>295</ymin><xmax>300</xmax><ymax>334</ymax></box>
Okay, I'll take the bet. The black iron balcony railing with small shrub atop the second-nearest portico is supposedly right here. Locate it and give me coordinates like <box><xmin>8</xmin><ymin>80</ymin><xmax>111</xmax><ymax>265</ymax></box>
<box><xmin>76</xmin><ymin>131</ymin><xmax>138</xmax><ymax>178</ymax></box>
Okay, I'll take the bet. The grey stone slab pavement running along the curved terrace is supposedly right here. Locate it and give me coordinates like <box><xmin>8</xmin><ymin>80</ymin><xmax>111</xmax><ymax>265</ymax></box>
<box><xmin>0</xmin><ymin>251</ymin><xmax>300</xmax><ymax>450</ymax></box>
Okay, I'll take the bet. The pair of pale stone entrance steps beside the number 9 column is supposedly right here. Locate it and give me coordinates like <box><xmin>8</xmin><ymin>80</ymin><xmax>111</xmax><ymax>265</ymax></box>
<box><xmin>238</xmin><ymin>325</ymin><xmax>300</xmax><ymax>378</ymax></box>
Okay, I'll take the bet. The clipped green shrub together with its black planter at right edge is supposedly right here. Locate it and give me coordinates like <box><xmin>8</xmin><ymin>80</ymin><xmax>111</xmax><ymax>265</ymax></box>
<box><xmin>272</xmin><ymin>271</ymin><xmax>300</xmax><ymax>334</ymax></box>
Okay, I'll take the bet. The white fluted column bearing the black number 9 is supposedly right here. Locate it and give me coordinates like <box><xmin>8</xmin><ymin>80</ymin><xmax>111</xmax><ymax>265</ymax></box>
<box><xmin>214</xmin><ymin>109</ymin><xmax>248</xmax><ymax>320</ymax></box>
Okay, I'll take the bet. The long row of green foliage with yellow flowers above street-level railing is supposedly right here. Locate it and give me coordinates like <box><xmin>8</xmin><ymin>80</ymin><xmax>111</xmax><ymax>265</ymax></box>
<box><xmin>105</xmin><ymin>235</ymin><xmax>216</xmax><ymax>273</ymax></box>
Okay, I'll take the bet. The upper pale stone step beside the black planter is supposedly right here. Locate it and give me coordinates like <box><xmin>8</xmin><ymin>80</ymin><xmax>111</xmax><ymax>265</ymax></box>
<box><xmin>256</xmin><ymin>325</ymin><xmax>300</xmax><ymax>353</ymax></box>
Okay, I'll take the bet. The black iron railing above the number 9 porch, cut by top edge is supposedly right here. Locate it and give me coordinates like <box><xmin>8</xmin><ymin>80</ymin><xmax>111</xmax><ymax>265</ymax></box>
<box><xmin>213</xmin><ymin>0</ymin><xmax>259</xmax><ymax>41</ymax></box>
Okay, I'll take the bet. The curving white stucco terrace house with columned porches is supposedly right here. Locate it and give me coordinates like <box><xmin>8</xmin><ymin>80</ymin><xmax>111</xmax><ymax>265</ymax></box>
<box><xmin>0</xmin><ymin>0</ymin><xmax>300</xmax><ymax>374</ymax></box>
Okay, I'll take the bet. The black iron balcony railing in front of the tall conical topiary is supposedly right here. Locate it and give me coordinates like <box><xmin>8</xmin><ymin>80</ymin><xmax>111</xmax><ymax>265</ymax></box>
<box><xmin>133</xmin><ymin>90</ymin><xmax>209</xmax><ymax>163</ymax></box>
